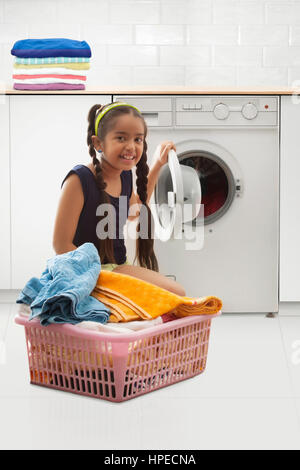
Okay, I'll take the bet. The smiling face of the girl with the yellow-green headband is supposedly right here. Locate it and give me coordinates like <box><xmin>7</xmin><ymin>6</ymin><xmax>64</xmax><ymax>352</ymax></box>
<box><xmin>100</xmin><ymin>114</ymin><xmax>144</xmax><ymax>171</ymax></box>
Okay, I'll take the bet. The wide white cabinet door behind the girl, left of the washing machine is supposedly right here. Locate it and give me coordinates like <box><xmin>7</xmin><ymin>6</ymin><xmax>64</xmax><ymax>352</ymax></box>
<box><xmin>10</xmin><ymin>94</ymin><xmax>111</xmax><ymax>289</ymax></box>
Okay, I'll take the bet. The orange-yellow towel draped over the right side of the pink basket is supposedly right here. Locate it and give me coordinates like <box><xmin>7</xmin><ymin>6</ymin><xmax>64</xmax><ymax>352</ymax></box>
<box><xmin>91</xmin><ymin>271</ymin><xmax>222</xmax><ymax>323</ymax></box>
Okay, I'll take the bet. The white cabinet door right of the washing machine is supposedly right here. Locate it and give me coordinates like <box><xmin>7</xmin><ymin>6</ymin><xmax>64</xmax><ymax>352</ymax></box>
<box><xmin>280</xmin><ymin>96</ymin><xmax>300</xmax><ymax>302</ymax></box>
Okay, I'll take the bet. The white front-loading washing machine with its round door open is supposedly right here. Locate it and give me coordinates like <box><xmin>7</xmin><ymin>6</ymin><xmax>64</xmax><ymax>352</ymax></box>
<box><xmin>114</xmin><ymin>95</ymin><xmax>279</xmax><ymax>313</ymax></box>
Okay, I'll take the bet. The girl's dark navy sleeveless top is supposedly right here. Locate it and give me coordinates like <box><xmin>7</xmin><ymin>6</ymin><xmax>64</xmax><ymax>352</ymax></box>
<box><xmin>61</xmin><ymin>165</ymin><xmax>132</xmax><ymax>264</ymax></box>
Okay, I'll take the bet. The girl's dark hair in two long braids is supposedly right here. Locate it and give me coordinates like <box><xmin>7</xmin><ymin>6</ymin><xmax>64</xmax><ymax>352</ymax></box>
<box><xmin>87</xmin><ymin>103</ymin><xmax>158</xmax><ymax>271</ymax></box>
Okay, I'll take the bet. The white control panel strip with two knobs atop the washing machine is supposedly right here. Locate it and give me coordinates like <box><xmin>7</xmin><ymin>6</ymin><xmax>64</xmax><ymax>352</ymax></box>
<box><xmin>114</xmin><ymin>95</ymin><xmax>279</xmax><ymax>128</ymax></box>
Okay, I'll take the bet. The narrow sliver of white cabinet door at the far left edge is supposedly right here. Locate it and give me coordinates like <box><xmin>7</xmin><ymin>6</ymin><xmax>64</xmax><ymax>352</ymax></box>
<box><xmin>0</xmin><ymin>96</ymin><xmax>11</xmax><ymax>289</ymax></box>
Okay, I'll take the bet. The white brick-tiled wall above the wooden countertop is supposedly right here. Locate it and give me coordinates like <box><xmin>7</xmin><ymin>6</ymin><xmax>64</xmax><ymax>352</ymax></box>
<box><xmin>0</xmin><ymin>0</ymin><xmax>300</xmax><ymax>87</ymax></box>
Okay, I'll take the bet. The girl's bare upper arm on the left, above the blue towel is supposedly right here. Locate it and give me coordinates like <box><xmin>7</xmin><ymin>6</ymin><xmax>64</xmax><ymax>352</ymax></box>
<box><xmin>52</xmin><ymin>174</ymin><xmax>84</xmax><ymax>255</ymax></box>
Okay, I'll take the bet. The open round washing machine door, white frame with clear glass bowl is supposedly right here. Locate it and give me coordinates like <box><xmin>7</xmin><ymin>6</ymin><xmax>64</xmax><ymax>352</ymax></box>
<box><xmin>151</xmin><ymin>150</ymin><xmax>201</xmax><ymax>241</ymax></box>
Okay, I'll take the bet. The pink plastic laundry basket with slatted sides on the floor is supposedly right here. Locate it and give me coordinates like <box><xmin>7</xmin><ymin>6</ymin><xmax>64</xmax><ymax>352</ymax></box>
<box><xmin>15</xmin><ymin>312</ymin><xmax>221</xmax><ymax>402</ymax></box>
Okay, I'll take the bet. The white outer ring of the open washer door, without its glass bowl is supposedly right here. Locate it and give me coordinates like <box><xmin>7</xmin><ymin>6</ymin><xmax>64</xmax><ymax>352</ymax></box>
<box><xmin>151</xmin><ymin>150</ymin><xmax>183</xmax><ymax>241</ymax></box>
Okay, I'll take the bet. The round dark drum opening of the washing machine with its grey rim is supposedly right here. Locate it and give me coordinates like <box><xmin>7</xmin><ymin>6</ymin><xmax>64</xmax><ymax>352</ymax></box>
<box><xmin>178</xmin><ymin>150</ymin><xmax>236</xmax><ymax>225</ymax></box>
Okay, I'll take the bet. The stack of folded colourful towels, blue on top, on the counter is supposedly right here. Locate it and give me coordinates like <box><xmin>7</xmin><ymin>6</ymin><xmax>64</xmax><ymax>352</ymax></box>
<box><xmin>11</xmin><ymin>38</ymin><xmax>92</xmax><ymax>90</ymax></box>
